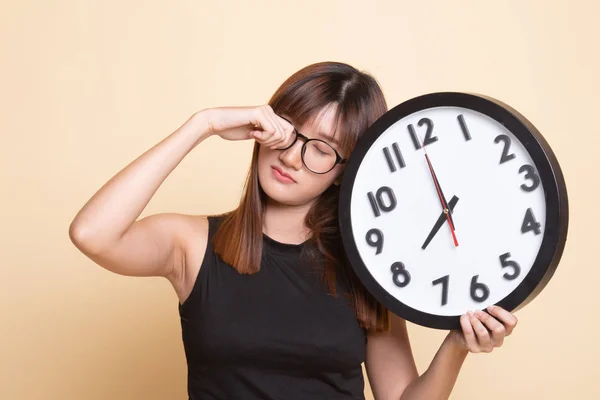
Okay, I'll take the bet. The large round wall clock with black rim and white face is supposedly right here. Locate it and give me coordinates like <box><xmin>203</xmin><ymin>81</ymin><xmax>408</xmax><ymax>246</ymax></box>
<box><xmin>339</xmin><ymin>92</ymin><xmax>568</xmax><ymax>329</ymax></box>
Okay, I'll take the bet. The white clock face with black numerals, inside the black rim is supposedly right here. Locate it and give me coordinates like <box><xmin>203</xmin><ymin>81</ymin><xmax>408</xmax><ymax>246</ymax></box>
<box><xmin>350</xmin><ymin>106</ymin><xmax>546</xmax><ymax>316</ymax></box>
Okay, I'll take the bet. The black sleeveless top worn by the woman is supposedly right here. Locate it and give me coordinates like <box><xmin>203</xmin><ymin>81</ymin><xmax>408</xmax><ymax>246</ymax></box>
<box><xmin>178</xmin><ymin>217</ymin><xmax>366</xmax><ymax>400</ymax></box>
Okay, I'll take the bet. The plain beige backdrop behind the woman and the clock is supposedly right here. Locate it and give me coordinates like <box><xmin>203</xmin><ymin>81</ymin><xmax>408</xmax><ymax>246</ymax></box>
<box><xmin>0</xmin><ymin>0</ymin><xmax>600</xmax><ymax>400</ymax></box>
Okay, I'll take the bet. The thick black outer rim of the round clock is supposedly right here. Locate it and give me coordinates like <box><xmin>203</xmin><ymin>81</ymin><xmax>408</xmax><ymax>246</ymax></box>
<box><xmin>339</xmin><ymin>92</ymin><xmax>569</xmax><ymax>329</ymax></box>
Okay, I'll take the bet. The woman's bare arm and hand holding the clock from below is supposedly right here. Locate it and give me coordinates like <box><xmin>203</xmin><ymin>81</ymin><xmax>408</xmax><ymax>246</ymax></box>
<box><xmin>366</xmin><ymin>306</ymin><xmax>517</xmax><ymax>400</ymax></box>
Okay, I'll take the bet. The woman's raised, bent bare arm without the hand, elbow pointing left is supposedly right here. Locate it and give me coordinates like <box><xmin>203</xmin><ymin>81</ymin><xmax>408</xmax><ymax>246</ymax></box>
<box><xmin>69</xmin><ymin>112</ymin><xmax>209</xmax><ymax>276</ymax></box>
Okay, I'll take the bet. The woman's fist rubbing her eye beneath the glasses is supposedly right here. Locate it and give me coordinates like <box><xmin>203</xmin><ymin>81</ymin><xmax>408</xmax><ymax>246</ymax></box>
<box><xmin>206</xmin><ymin>105</ymin><xmax>294</xmax><ymax>149</ymax></box>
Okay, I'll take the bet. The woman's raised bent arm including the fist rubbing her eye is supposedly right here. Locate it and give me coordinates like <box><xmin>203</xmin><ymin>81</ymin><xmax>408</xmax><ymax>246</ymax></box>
<box><xmin>69</xmin><ymin>106</ymin><xmax>293</xmax><ymax>282</ymax></box>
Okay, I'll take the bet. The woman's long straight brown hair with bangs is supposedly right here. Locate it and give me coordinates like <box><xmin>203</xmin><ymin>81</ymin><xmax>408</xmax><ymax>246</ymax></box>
<box><xmin>213</xmin><ymin>62</ymin><xmax>389</xmax><ymax>331</ymax></box>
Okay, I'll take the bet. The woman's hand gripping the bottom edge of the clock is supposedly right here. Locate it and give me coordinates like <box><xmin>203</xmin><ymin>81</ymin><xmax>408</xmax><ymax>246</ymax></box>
<box><xmin>448</xmin><ymin>306</ymin><xmax>518</xmax><ymax>353</ymax></box>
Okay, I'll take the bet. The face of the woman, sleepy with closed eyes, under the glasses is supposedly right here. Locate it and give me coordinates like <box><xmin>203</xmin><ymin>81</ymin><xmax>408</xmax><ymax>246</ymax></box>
<box><xmin>258</xmin><ymin>106</ymin><xmax>346</xmax><ymax>206</ymax></box>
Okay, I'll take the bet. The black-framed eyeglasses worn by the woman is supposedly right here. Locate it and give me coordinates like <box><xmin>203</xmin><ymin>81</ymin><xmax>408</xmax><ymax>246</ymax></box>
<box><xmin>277</xmin><ymin>117</ymin><xmax>347</xmax><ymax>174</ymax></box>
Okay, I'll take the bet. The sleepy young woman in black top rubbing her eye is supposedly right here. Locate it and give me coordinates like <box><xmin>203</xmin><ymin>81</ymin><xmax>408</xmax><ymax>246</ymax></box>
<box><xmin>69</xmin><ymin>62</ymin><xmax>517</xmax><ymax>400</ymax></box>
